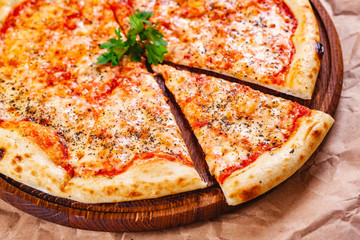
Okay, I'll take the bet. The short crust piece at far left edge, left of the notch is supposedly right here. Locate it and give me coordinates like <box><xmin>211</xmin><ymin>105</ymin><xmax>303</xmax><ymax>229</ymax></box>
<box><xmin>0</xmin><ymin>128</ymin><xmax>70</xmax><ymax>197</ymax></box>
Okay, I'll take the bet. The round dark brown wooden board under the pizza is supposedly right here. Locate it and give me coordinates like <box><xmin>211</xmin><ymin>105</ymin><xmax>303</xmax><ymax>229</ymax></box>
<box><xmin>0</xmin><ymin>0</ymin><xmax>343</xmax><ymax>231</ymax></box>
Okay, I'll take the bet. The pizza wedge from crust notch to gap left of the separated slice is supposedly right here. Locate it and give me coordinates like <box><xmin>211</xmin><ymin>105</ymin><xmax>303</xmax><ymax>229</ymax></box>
<box><xmin>65</xmin><ymin>58</ymin><xmax>206</xmax><ymax>203</ymax></box>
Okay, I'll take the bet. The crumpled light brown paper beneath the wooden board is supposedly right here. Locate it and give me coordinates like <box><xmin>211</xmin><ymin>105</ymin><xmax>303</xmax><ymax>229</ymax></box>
<box><xmin>0</xmin><ymin>0</ymin><xmax>360</xmax><ymax>240</ymax></box>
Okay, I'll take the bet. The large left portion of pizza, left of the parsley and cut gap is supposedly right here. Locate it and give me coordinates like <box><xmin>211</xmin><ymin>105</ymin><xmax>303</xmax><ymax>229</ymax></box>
<box><xmin>0</xmin><ymin>0</ymin><xmax>206</xmax><ymax>202</ymax></box>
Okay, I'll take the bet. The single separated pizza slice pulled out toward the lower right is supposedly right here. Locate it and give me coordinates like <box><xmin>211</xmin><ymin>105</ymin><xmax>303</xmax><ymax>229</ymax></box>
<box><xmin>153</xmin><ymin>65</ymin><xmax>334</xmax><ymax>205</ymax></box>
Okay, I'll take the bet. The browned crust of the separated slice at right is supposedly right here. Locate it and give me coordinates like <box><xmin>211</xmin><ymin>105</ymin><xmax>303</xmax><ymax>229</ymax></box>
<box><xmin>221</xmin><ymin>110</ymin><xmax>334</xmax><ymax>205</ymax></box>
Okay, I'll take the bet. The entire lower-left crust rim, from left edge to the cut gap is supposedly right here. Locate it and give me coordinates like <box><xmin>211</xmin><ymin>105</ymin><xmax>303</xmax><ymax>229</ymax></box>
<box><xmin>0</xmin><ymin>124</ymin><xmax>207</xmax><ymax>203</ymax></box>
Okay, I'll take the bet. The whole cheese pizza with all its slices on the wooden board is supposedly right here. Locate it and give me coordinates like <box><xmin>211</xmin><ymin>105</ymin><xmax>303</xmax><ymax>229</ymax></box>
<box><xmin>0</xmin><ymin>0</ymin><xmax>333</xmax><ymax>205</ymax></box>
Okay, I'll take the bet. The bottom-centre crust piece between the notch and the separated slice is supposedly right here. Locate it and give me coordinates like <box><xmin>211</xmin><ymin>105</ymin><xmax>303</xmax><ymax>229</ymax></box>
<box><xmin>65</xmin><ymin>158</ymin><xmax>206</xmax><ymax>203</ymax></box>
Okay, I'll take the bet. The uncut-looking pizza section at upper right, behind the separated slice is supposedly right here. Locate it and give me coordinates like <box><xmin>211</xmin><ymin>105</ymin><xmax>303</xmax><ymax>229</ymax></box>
<box><xmin>115</xmin><ymin>0</ymin><xmax>321</xmax><ymax>99</ymax></box>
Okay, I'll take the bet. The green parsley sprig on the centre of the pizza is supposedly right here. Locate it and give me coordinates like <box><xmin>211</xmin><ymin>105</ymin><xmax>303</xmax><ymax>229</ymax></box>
<box><xmin>95</xmin><ymin>10</ymin><xmax>167</xmax><ymax>66</ymax></box>
